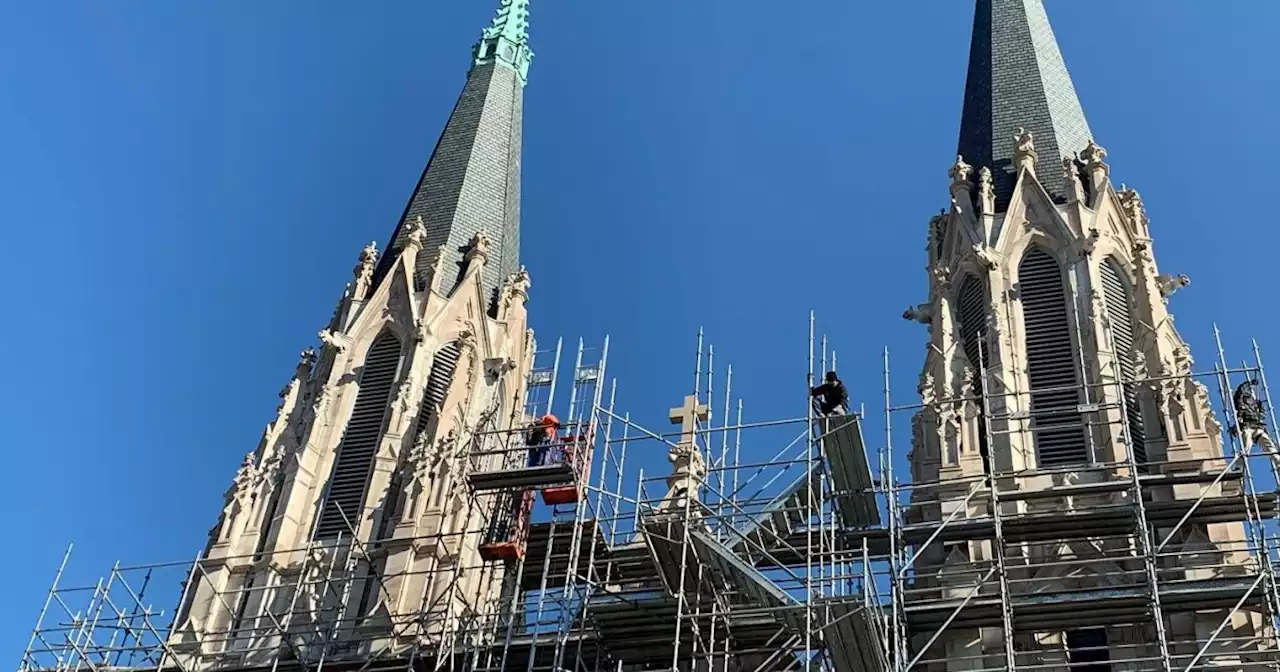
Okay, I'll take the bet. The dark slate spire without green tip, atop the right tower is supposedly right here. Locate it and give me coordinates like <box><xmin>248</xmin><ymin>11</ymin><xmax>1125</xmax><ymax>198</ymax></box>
<box><xmin>959</xmin><ymin>0</ymin><xmax>1092</xmax><ymax>210</ymax></box>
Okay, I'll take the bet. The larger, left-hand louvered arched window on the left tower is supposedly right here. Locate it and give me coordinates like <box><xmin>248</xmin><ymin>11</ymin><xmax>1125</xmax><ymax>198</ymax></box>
<box><xmin>315</xmin><ymin>332</ymin><xmax>401</xmax><ymax>539</ymax></box>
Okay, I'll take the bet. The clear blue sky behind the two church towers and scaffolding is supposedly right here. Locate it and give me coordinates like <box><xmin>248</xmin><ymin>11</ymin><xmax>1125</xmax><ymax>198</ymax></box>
<box><xmin>0</xmin><ymin>0</ymin><xmax>1280</xmax><ymax>660</ymax></box>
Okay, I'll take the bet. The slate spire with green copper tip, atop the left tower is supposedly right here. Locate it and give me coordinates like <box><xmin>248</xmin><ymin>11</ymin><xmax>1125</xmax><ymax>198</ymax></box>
<box><xmin>375</xmin><ymin>0</ymin><xmax>532</xmax><ymax>312</ymax></box>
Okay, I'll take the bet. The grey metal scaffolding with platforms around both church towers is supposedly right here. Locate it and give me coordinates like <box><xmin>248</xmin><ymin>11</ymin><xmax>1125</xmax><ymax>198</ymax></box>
<box><xmin>19</xmin><ymin>316</ymin><xmax>1280</xmax><ymax>672</ymax></box>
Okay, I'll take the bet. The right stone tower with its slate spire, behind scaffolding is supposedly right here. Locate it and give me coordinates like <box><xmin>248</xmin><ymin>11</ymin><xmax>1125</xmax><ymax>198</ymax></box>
<box><xmin>904</xmin><ymin>0</ymin><xmax>1262</xmax><ymax>671</ymax></box>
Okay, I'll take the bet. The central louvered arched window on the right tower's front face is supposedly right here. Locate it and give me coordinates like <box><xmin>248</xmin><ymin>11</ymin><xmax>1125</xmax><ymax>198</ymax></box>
<box><xmin>1018</xmin><ymin>250</ymin><xmax>1089</xmax><ymax>467</ymax></box>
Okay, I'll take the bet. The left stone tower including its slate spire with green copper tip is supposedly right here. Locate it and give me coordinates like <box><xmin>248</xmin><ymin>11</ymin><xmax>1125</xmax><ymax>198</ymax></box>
<box><xmin>170</xmin><ymin>0</ymin><xmax>532</xmax><ymax>668</ymax></box>
